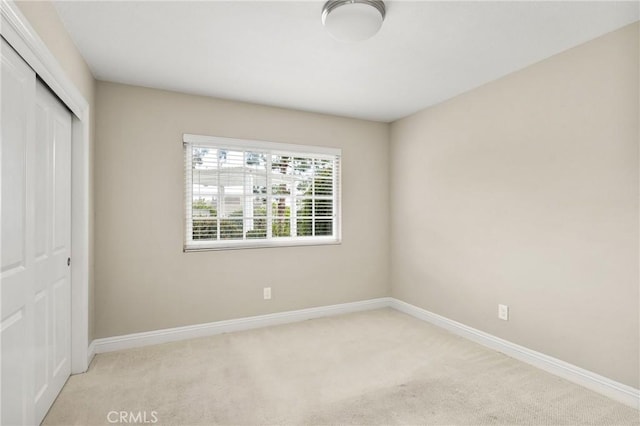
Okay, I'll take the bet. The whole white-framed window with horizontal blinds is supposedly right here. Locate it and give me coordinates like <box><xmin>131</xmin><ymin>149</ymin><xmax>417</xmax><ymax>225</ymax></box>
<box><xmin>184</xmin><ymin>134</ymin><xmax>341</xmax><ymax>251</ymax></box>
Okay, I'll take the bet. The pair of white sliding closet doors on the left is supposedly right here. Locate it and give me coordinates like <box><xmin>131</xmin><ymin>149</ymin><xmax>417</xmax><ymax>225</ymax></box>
<box><xmin>0</xmin><ymin>40</ymin><xmax>71</xmax><ymax>425</ymax></box>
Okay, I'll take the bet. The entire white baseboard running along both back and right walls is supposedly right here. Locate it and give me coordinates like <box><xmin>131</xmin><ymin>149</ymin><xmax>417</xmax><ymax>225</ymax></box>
<box><xmin>88</xmin><ymin>297</ymin><xmax>640</xmax><ymax>409</ymax></box>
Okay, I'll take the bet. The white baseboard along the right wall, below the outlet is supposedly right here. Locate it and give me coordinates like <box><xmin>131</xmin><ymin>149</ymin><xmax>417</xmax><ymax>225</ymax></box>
<box><xmin>389</xmin><ymin>298</ymin><xmax>640</xmax><ymax>410</ymax></box>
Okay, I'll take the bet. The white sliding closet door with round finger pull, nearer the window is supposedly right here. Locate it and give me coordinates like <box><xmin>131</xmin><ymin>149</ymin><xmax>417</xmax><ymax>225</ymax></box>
<box><xmin>33</xmin><ymin>75</ymin><xmax>71</xmax><ymax>423</ymax></box>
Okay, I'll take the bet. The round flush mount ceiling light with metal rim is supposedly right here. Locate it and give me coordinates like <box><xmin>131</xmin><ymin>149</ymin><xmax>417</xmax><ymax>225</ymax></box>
<box><xmin>322</xmin><ymin>0</ymin><xmax>386</xmax><ymax>41</ymax></box>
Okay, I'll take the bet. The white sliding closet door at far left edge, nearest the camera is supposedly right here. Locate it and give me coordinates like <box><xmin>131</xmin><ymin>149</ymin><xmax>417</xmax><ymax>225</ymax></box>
<box><xmin>0</xmin><ymin>35</ymin><xmax>36</xmax><ymax>425</ymax></box>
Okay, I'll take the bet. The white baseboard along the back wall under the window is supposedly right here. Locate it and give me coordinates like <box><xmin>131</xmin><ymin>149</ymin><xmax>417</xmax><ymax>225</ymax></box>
<box><xmin>89</xmin><ymin>297</ymin><xmax>391</xmax><ymax>354</ymax></box>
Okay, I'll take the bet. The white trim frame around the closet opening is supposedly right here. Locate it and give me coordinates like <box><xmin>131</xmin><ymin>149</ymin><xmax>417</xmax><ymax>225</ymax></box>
<box><xmin>0</xmin><ymin>0</ymin><xmax>93</xmax><ymax>374</ymax></box>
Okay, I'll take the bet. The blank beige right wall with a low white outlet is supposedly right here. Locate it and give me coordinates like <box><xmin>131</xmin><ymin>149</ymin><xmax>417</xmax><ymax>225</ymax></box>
<box><xmin>391</xmin><ymin>23</ymin><xmax>640</xmax><ymax>388</ymax></box>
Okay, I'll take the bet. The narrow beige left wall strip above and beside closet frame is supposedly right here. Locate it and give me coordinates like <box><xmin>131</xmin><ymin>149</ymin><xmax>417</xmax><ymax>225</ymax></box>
<box><xmin>16</xmin><ymin>1</ymin><xmax>95</xmax><ymax>341</ymax></box>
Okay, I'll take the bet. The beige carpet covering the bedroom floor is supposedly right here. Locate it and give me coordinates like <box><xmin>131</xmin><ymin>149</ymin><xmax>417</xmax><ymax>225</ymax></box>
<box><xmin>44</xmin><ymin>309</ymin><xmax>640</xmax><ymax>425</ymax></box>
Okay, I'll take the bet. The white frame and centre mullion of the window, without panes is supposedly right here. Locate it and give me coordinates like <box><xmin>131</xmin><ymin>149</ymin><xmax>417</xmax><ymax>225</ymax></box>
<box><xmin>182</xmin><ymin>133</ymin><xmax>342</xmax><ymax>253</ymax></box>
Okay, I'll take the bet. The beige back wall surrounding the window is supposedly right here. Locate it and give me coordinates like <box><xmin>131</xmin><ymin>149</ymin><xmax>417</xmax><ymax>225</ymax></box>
<box><xmin>95</xmin><ymin>82</ymin><xmax>390</xmax><ymax>337</ymax></box>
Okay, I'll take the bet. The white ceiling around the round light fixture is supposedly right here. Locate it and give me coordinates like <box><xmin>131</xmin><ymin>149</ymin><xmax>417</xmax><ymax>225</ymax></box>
<box><xmin>55</xmin><ymin>0</ymin><xmax>640</xmax><ymax>122</ymax></box>
